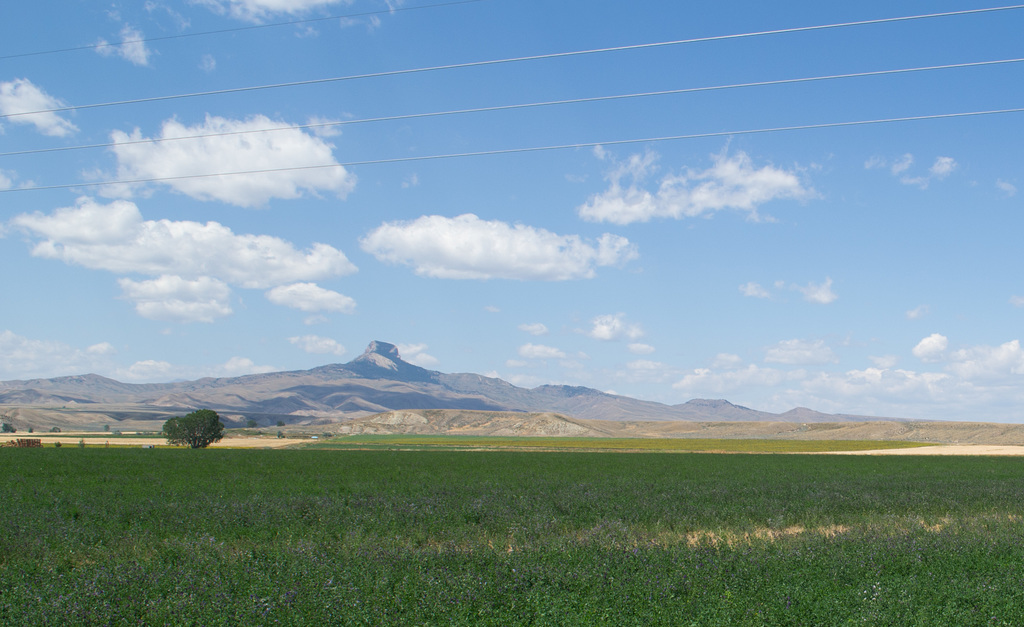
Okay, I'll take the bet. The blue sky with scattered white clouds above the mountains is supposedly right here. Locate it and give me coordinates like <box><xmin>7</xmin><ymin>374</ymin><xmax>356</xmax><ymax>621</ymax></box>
<box><xmin>0</xmin><ymin>0</ymin><xmax>1024</xmax><ymax>422</ymax></box>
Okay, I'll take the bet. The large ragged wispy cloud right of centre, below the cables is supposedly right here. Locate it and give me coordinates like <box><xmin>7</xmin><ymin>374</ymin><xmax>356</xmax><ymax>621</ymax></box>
<box><xmin>577</xmin><ymin>150</ymin><xmax>814</xmax><ymax>224</ymax></box>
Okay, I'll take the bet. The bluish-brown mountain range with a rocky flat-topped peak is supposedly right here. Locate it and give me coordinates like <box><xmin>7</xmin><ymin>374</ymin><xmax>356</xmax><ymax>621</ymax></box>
<box><xmin>0</xmin><ymin>341</ymin><xmax>897</xmax><ymax>424</ymax></box>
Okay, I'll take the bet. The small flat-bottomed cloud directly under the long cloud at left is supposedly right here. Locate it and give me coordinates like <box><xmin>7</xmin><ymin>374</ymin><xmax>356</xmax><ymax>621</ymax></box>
<box><xmin>118</xmin><ymin>275</ymin><xmax>231</xmax><ymax>323</ymax></box>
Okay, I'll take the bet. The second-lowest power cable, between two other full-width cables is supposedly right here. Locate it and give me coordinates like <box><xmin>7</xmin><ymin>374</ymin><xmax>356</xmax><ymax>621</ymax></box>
<box><xmin>0</xmin><ymin>57</ymin><xmax>1024</xmax><ymax>157</ymax></box>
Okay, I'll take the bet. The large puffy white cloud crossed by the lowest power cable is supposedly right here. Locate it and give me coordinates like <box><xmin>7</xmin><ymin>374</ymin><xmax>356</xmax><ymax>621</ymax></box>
<box><xmin>110</xmin><ymin>115</ymin><xmax>355</xmax><ymax>207</ymax></box>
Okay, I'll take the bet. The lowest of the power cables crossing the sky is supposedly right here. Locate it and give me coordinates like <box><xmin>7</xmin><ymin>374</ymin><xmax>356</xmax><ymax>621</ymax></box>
<box><xmin>0</xmin><ymin>107</ymin><xmax>1024</xmax><ymax>194</ymax></box>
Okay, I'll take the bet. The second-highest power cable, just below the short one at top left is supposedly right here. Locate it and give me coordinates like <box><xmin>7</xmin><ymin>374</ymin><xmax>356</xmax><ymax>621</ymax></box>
<box><xmin>0</xmin><ymin>4</ymin><xmax>1024</xmax><ymax>119</ymax></box>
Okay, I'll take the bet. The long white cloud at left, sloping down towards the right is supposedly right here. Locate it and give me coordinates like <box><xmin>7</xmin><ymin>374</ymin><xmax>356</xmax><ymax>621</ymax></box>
<box><xmin>11</xmin><ymin>198</ymin><xmax>356</xmax><ymax>289</ymax></box>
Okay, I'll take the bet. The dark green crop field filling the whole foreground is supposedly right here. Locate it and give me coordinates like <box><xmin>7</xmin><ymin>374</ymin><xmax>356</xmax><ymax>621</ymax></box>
<box><xmin>0</xmin><ymin>447</ymin><xmax>1024</xmax><ymax>625</ymax></box>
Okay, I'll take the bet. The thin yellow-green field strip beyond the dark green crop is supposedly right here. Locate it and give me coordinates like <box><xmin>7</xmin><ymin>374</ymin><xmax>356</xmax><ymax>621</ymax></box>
<box><xmin>310</xmin><ymin>435</ymin><xmax>934</xmax><ymax>453</ymax></box>
